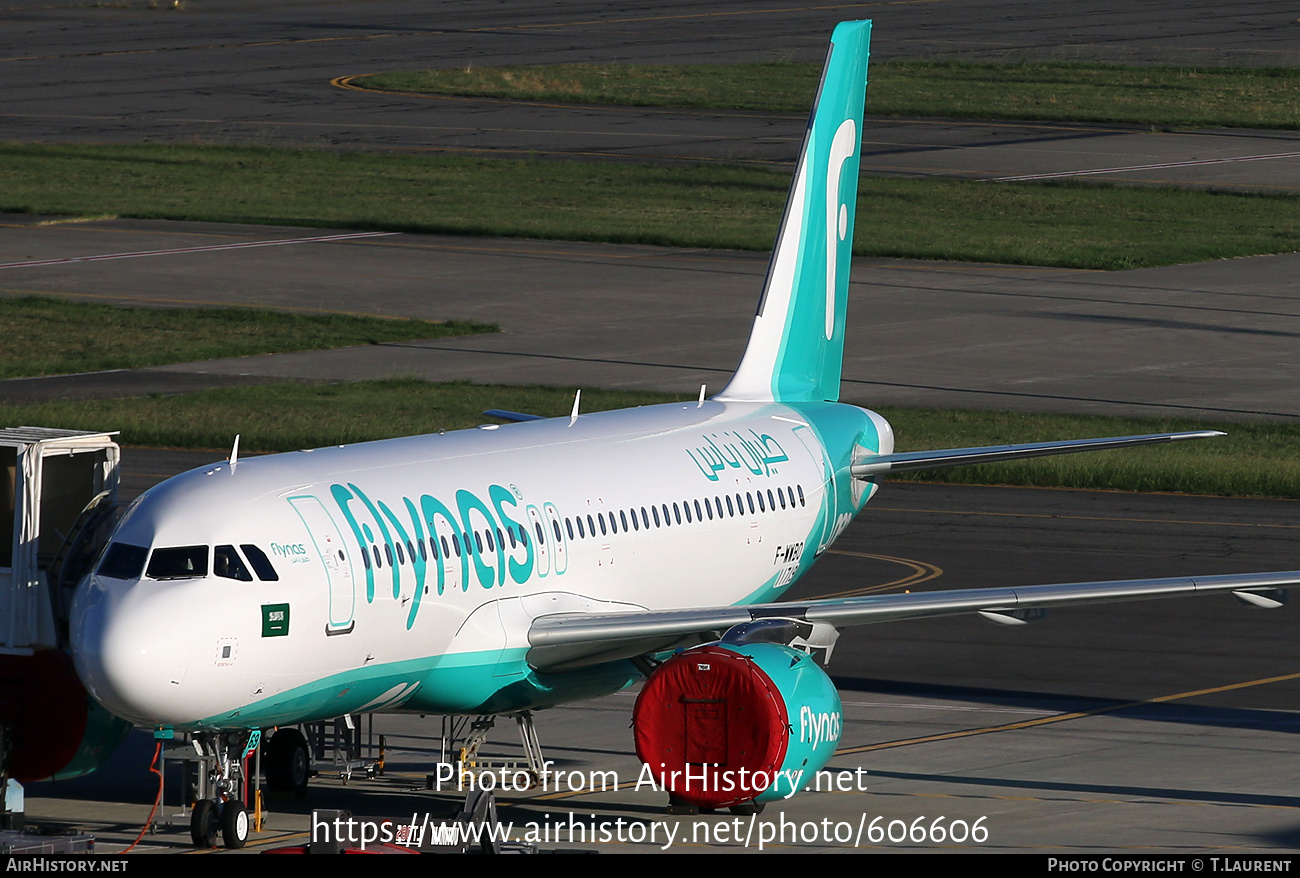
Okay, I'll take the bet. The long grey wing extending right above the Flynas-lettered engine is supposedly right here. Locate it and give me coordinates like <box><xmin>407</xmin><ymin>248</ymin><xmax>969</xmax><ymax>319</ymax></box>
<box><xmin>528</xmin><ymin>571</ymin><xmax>1300</xmax><ymax>671</ymax></box>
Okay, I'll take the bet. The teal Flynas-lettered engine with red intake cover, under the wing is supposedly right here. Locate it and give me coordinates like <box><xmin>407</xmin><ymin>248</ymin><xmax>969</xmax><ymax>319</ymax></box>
<box><xmin>632</xmin><ymin>643</ymin><xmax>842</xmax><ymax>808</ymax></box>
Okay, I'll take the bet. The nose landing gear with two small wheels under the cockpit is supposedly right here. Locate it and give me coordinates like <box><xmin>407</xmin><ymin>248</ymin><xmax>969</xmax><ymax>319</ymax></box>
<box><xmin>190</xmin><ymin>731</ymin><xmax>253</xmax><ymax>848</ymax></box>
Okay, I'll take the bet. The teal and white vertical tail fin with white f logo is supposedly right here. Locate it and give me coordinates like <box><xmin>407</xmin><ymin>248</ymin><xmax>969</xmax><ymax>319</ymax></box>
<box><xmin>718</xmin><ymin>21</ymin><xmax>871</xmax><ymax>402</ymax></box>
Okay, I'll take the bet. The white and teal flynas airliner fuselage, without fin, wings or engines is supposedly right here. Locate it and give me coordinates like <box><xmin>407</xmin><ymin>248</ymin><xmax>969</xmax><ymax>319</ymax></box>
<box><xmin>73</xmin><ymin>401</ymin><xmax>893</xmax><ymax>728</ymax></box>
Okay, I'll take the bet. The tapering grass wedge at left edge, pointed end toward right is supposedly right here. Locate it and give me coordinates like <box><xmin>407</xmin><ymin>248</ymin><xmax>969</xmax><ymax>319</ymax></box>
<box><xmin>0</xmin><ymin>297</ymin><xmax>497</xmax><ymax>379</ymax></box>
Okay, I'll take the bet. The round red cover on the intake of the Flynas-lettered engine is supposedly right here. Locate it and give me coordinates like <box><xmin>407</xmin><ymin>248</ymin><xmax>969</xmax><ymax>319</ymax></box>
<box><xmin>632</xmin><ymin>646</ymin><xmax>790</xmax><ymax>808</ymax></box>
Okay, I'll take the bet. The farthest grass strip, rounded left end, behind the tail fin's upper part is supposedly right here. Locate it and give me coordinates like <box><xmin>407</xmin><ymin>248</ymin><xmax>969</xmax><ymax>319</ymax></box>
<box><xmin>361</xmin><ymin>61</ymin><xmax>1300</xmax><ymax>129</ymax></box>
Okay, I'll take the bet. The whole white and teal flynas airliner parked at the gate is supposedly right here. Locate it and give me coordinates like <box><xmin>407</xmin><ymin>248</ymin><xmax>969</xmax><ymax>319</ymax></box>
<box><xmin>72</xmin><ymin>22</ymin><xmax>1300</xmax><ymax>845</ymax></box>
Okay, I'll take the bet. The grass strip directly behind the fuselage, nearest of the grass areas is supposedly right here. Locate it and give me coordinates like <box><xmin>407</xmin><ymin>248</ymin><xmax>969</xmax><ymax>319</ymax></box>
<box><xmin>0</xmin><ymin>380</ymin><xmax>1300</xmax><ymax>499</ymax></box>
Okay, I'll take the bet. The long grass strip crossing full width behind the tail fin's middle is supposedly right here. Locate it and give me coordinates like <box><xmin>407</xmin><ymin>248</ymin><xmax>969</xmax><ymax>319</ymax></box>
<box><xmin>0</xmin><ymin>144</ymin><xmax>1300</xmax><ymax>269</ymax></box>
